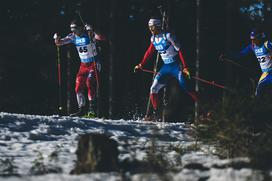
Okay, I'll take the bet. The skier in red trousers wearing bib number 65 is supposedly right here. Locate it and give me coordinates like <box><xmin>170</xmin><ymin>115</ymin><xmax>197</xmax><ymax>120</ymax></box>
<box><xmin>54</xmin><ymin>21</ymin><xmax>105</xmax><ymax>116</ymax></box>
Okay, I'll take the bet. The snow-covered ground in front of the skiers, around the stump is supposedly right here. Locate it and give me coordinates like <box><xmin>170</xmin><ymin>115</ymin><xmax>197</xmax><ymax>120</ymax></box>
<box><xmin>0</xmin><ymin>112</ymin><xmax>271</xmax><ymax>181</ymax></box>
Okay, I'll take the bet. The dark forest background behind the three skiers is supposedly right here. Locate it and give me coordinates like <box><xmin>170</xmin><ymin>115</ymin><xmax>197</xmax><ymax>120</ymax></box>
<box><xmin>0</xmin><ymin>0</ymin><xmax>272</xmax><ymax>119</ymax></box>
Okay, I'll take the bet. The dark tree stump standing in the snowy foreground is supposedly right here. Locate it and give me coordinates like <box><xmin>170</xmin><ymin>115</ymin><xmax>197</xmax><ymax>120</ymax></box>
<box><xmin>71</xmin><ymin>134</ymin><xmax>119</xmax><ymax>174</ymax></box>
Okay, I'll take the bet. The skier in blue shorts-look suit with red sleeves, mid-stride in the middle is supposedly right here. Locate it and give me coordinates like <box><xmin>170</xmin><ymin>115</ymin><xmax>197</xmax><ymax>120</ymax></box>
<box><xmin>134</xmin><ymin>18</ymin><xmax>198</xmax><ymax>118</ymax></box>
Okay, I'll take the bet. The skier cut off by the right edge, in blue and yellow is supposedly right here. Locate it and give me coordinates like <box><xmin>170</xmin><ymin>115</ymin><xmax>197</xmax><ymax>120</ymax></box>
<box><xmin>238</xmin><ymin>30</ymin><xmax>272</xmax><ymax>96</ymax></box>
